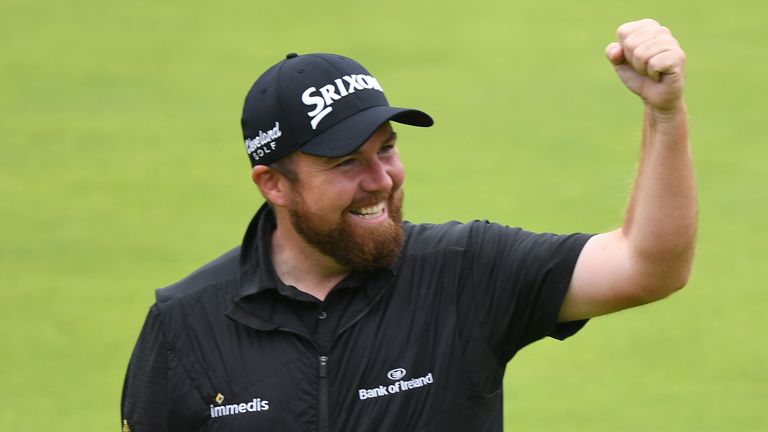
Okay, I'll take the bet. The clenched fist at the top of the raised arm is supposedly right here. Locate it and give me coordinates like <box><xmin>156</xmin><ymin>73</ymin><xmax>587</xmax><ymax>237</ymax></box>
<box><xmin>605</xmin><ymin>19</ymin><xmax>685</xmax><ymax>114</ymax></box>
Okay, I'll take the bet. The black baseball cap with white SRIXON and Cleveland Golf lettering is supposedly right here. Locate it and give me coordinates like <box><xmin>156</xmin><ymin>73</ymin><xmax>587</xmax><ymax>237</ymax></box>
<box><xmin>241</xmin><ymin>53</ymin><xmax>434</xmax><ymax>166</ymax></box>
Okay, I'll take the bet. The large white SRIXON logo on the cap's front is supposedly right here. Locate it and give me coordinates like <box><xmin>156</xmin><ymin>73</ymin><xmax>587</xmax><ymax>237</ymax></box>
<box><xmin>301</xmin><ymin>74</ymin><xmax>384</xmax><ymax>130</ymax></box>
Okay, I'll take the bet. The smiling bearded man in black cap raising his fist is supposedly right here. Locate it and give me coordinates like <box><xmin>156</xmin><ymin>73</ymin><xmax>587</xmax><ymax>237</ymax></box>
<box><xmin>122</xmin><ymin>20</ymin><xmax>696</xmax><ymax>432</ymax></box>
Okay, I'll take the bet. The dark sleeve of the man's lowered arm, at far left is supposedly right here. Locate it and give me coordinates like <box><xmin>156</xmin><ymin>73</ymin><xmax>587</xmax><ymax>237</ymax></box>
<box><xmin>121</xmin><ymin>305</ymin><xmax>169</xmax><ymax>432</ymax></box>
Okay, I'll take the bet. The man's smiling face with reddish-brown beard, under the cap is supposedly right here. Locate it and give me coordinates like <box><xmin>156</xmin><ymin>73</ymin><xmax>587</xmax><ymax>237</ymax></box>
<box><xmin>286</xmin><ymin>123</ymin><xmax>405</xmax><ymax>270</ymax></box>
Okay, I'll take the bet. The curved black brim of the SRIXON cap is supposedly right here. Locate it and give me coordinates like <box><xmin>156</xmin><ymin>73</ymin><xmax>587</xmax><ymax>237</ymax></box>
<box><xmin>298</xmin><ymin>105</ymin><xmax>434</xmax><ymax>157</ymax></box>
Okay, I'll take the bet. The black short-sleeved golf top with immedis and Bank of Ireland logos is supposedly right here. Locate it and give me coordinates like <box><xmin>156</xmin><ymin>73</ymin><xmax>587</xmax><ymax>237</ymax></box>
<box><xmin>122</xmin><ymin>208</ymin><xmax>588</xmax><ymax>432</ymax></box>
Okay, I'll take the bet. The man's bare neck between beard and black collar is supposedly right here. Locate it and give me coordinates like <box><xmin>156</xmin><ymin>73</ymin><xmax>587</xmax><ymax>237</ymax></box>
<box><xmin>269</xmin><ymin>219</ymin><xmax>349</xmax><ymax>300</ymax></box>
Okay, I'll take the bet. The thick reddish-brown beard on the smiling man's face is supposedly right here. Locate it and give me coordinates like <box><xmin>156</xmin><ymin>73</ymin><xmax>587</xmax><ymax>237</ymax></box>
<box><xmin>288</xmin><ymin>189</ymin><xmax>403</xmax><ymax>271</ymax></box>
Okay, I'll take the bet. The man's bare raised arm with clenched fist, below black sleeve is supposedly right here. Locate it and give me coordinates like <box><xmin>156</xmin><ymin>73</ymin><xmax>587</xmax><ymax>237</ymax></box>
<box><xmin>559</xmin><ymin>20</ymin><xmax>697</xmax><ymax>321</ymax></box>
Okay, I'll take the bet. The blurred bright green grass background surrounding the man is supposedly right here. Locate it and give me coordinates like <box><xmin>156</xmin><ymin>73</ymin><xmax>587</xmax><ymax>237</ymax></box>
<box><xmin>0</xmin><ymin>0</ymin><xmax>768</xmax><ymax>432</ymax></box>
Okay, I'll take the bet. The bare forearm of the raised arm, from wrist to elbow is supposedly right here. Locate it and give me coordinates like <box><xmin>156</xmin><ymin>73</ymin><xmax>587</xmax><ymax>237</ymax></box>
<box><xmin>622</xmin><ymin>102</ymin><xmax>697</xmax><ymax>289</ymax></box>
